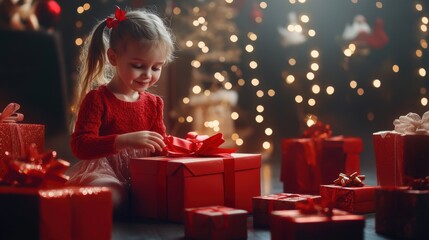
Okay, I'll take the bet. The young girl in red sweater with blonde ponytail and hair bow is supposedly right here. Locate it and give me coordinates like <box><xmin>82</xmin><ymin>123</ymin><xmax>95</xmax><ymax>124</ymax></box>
<box><xmin>67</xmin><ymin>7</ymin><xmax>174</xmax><ymax>212</ymax></box>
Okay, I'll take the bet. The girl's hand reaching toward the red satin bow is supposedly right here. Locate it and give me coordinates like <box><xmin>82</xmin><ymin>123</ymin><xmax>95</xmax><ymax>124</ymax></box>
<box><xmin>115</xmin><ymin>131</ymin><xmax>165</xmax><ymax>152</ymax></box>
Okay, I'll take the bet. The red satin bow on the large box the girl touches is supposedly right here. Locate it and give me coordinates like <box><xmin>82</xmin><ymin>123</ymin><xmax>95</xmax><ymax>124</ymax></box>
<box><xmin>164</xmin><ymin>132</ymin><xmax>236</xmax><ymax>157</ymax></box>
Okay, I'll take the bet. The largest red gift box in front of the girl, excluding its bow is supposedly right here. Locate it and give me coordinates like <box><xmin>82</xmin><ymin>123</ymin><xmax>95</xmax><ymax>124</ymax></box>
<box><xmin>130</xmin><ymin>153</ymin><xmax>261</xmax><ymax>221</ymax></box>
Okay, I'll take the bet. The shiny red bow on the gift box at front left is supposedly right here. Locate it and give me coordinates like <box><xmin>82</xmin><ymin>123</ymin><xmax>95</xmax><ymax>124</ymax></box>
<box><xmin>0</xmin><ymin>143</ymin><xmax>70</xmax><ymax>188</ymax></box>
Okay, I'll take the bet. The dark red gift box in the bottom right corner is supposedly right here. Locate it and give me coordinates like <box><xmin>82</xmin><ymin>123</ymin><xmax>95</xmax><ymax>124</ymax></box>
<box><xmin>375</xmin><ymin>187</ymin><xmax>429</xmax><ymax>239</ymax></box>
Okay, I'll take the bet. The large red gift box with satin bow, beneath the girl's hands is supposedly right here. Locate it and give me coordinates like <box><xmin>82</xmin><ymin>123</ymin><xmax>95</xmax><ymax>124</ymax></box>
<box><xmin>130</xmin><ymin>134</ymin><xmax>261</xmax><ymax>221</ymax></box>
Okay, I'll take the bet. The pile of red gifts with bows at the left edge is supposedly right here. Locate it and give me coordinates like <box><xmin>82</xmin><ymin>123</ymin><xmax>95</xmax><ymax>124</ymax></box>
<box><xmin>0</xmin><ymin>103</ymin><xmax>112</xmax><ymax>240</ymax></box>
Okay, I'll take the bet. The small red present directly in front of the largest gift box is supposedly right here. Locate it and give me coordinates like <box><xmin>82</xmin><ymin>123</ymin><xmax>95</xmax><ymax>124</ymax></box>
<box><xmin>185</xmin><ymin>206</ymin><xmax>248</xmax><ymax>239</ymax></box>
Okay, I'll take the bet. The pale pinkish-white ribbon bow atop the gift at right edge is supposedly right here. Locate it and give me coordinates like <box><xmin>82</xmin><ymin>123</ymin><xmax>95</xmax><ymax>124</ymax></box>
<box><xmin>393</xmin><ymin>111</ymin><xmax>429</xmax><ymax>135</ymax></box>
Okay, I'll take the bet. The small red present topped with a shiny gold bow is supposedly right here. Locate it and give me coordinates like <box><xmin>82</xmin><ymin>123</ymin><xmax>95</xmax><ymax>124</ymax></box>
<box><xmin>320</xmin><ymin>172</ymin><xmax>379</xmax><ymax>214</ymax></box>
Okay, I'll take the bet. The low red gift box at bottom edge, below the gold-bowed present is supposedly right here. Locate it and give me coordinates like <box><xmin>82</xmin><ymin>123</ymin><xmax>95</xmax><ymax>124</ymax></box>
<box><xmin>270</xmin><ymin>209</ymin><xmax>365</xmax><ymax>240</ymax></box>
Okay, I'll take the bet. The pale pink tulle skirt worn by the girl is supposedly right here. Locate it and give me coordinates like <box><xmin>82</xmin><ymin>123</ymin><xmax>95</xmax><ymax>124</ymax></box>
<box><xmin>66</xmin><ymin>149</ymin><xmax>151</xmax><ymax>188</ymax></box>
